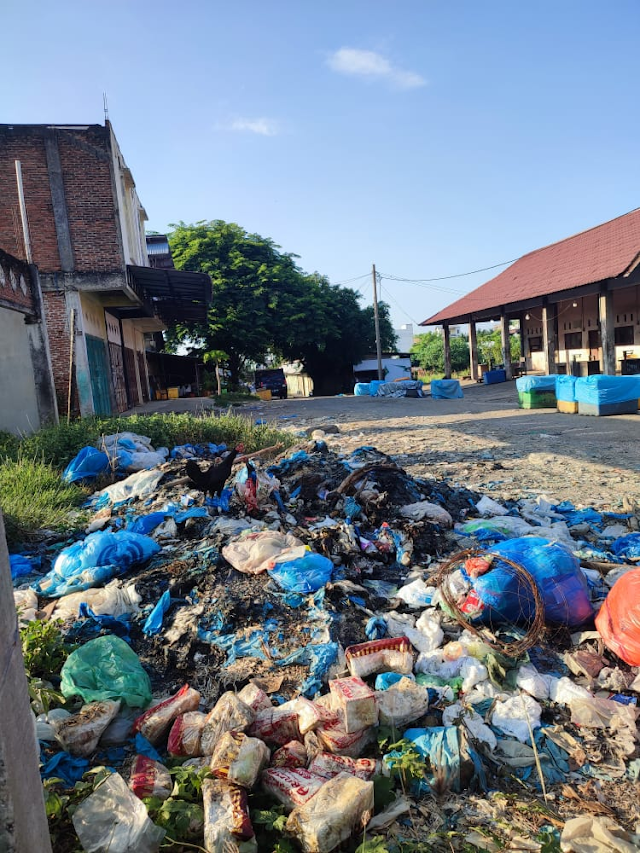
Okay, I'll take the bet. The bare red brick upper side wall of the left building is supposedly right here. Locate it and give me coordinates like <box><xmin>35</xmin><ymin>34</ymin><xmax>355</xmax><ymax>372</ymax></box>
<box><xmin>0</xmin><ymin>125</ymin><xmax>124</xmax><ymax>273</ymax></box>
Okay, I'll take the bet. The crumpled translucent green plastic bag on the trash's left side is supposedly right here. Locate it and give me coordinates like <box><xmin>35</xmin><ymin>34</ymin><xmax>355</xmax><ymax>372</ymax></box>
<box><xmin>61</xmin><ymin>634</ymin><xmax>151</xmax><ymax>708</ymax></box>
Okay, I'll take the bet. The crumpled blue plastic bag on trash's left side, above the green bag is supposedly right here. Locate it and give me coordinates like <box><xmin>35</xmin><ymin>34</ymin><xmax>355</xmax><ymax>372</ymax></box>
<box><xmin>33</xmin><ymin>530</ymin><xmax>160</xmax><ymax>598</ymax></box>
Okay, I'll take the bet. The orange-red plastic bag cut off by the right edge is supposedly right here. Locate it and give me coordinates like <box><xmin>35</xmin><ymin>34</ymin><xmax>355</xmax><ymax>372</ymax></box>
<box><xmin>596</xmin><ymin>569</ymin><xmax>640</xmax><ymax>666</ymax></box>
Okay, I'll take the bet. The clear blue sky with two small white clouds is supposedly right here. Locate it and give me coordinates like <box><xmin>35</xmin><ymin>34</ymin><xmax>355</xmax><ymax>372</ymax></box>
<box><xmin>0</xmin><ymin>0</ymin><xmax>640</xmax><ymax>325</ymax></box>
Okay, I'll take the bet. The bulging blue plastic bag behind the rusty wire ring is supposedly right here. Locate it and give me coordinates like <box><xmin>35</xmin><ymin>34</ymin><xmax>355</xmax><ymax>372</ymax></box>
<box><xmin>473</xmin><ymin>536</ymin><xmax>593</xmax><ymax>628</ymax></box>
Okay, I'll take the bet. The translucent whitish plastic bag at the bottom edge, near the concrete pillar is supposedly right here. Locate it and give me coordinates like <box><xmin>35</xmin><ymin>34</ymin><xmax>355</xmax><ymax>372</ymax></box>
<box><xmin>71</xmin><ymin>773</ymin><xmax>165</xmax><ymax>853</ymax></box>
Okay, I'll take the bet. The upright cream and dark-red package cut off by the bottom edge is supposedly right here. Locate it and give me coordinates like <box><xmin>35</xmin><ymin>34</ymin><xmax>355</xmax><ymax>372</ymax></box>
<box><xmin>202</xmin><ymin>779</ymin><xmax>258</xmax><ymax>853</ymax></box>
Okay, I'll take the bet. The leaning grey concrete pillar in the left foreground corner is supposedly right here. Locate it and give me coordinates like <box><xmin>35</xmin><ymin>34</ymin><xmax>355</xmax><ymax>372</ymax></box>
<box><xmin>0</xmin><ymin>513</ymin><xmax>51</xmax><ymax>853</ymax></box>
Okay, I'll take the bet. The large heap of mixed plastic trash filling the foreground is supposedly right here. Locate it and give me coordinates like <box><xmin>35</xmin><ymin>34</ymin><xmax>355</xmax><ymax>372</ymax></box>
<box><xmin>11</xmin><ymin>434</ymin><xmax>640</xmax><ymax>853</ymax></box>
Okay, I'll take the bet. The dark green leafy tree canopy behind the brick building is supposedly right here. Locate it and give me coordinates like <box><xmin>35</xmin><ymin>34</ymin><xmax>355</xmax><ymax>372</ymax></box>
<box><xmin>169</xmin><ymin>220</ymin><xmax>396</xmax><ymax>393</ymax></box>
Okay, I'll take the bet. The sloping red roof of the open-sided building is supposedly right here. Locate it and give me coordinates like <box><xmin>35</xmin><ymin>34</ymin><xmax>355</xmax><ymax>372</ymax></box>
<box><xmin>421</xmin><ymin>208</ymin><xmax>640</xmax><ymax>326</ymax></box>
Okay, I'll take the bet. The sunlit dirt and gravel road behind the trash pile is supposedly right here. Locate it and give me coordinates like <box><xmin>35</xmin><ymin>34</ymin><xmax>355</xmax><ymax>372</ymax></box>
<box><xmin>135</xmin><ymin>382</ymin><xmax>640</xmax><ymax>509</ymax></box>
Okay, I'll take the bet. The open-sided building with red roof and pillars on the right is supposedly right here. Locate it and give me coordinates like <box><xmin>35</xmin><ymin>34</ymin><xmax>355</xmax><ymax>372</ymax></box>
<box><xmin>421</xmin><ymin>208</ymin><xmax>640</xmax><ymax>378</ymax></box>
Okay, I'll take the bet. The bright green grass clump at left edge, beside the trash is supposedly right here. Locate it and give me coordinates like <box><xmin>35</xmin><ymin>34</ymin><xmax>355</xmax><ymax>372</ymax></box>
<box><xmin>0</xmin><ymin>455</ymin><xmax>86</xmax><ymax>546</ymax></box>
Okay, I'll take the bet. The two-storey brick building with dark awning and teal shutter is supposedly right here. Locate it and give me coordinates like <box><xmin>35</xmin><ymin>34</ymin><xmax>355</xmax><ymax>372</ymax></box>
<box><xmin>0</xmin><ymin>121</ymin><xmax>211</xmax><ymax>415</ymax></box>
